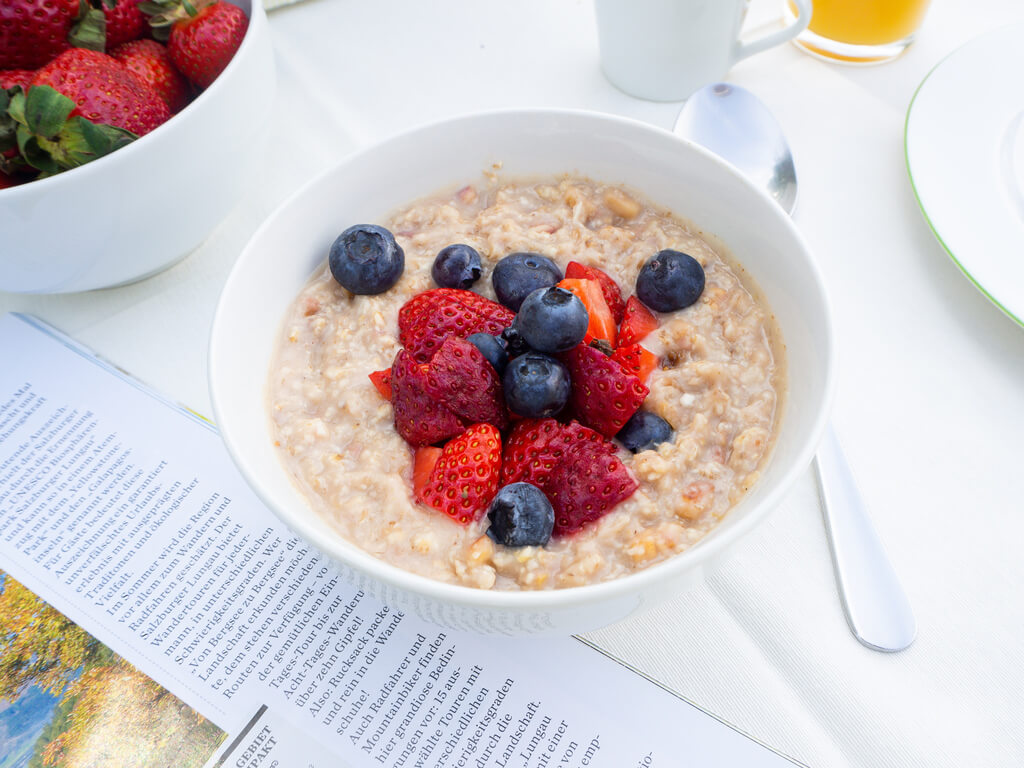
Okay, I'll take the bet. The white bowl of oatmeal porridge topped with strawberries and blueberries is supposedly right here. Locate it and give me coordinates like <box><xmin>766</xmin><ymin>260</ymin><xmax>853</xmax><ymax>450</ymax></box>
<box><xmin>209</xmin><ymin>111</ymin><xmax>834</xmax><ymax>634</ymax></box>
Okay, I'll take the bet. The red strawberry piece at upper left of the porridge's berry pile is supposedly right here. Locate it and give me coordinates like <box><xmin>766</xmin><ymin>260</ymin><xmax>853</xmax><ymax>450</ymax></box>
<box><xmin>398</xmin><ymin>288</ymin><xmax>515</xmax><ymax>362</ymax></box>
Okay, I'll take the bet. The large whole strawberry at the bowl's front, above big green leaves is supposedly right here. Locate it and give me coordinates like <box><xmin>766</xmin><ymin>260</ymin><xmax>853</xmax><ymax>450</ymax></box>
<box><xmin>32</xmin><ymin>48</ymin><xmax>171</xmax><ymax>136</ymax></box>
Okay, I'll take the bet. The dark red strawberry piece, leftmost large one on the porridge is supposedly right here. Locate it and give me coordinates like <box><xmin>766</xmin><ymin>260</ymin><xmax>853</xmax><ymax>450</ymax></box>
<box><xmin>391</xmin><ymin>349</ymin><xmax>464</xmax><ymax>445</ymax></box>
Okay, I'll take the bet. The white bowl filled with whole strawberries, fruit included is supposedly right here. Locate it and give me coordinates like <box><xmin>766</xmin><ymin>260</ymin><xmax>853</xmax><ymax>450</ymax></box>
<box><xmin>0</xmin><ymin>0</ymin><xmax>274</xmax><ymax>293</ymax></box>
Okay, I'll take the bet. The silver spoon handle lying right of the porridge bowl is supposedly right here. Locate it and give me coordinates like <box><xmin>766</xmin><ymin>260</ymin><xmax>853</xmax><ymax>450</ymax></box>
<box><xmin>814</xmin><ymin>424</ymin><xmax>918</xmax><ymax>652</ymax></box>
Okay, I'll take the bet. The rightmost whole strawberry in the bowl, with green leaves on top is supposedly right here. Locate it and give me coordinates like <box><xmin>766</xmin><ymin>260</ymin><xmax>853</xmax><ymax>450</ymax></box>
<box><xmin>139</xmin><ymin>0</ymin><xmax>249</xmax><ymax>88</ymax></box>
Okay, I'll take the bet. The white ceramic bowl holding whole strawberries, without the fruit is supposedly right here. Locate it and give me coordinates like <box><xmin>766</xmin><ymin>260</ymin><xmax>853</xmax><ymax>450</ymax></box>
<box><xmin>0</xmin><ymin>0</ymin><xmax>274</xmax><ymax>293</ymax></box>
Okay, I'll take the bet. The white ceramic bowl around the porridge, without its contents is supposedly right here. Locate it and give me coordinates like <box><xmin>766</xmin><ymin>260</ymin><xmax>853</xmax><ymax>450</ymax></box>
<box><xmin>209</xmin><ymin>111</ymin><xmax>834</xmax><ymax>634</ymax></box>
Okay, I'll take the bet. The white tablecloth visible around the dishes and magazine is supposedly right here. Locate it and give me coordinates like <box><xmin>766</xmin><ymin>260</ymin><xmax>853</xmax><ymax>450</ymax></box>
<box><xmin>0</xmin><ymin>0</ymin><xmax>1024</xmax><ymax>767</ymax></box>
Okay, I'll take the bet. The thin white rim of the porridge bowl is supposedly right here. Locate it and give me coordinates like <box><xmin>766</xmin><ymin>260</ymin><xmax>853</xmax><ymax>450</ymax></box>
<box><xmin>207</xmin><ymin>108</ymin><xmax>838</xmax><ymax>611</ymax></box>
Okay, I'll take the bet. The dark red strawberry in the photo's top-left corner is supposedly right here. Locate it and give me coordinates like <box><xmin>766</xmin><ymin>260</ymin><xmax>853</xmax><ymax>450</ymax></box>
<box><xmin>0</xmin><ymin>0</ymin><xmax>79</xmax><ymax>70</ymax></box>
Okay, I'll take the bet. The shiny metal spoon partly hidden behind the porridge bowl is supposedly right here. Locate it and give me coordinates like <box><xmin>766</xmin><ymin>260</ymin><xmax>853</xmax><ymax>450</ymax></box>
<box><xmin>675</xmin><ymin>83</ymin><xmax>918</xmax><ymax>652</ymax></box>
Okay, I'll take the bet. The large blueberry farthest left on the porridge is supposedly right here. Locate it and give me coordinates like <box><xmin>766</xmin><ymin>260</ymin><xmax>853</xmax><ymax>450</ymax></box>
<box><xmin>328</xmin><ymin>224</ymin><xmax>406</xmax><ymax>295</ymax></box>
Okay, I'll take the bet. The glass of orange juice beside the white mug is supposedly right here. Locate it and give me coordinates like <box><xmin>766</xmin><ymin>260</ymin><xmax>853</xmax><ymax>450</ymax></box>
<box><xmin>785</xmin><ymin>0</ymin><xmax>930</xmax><ymax>63</ymax></box>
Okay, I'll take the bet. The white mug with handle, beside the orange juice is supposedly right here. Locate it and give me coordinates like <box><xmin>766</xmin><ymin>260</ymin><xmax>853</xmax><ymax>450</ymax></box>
<box><xmin>595</xmin><ymin>0</ymin><xmax>811</xmax><ymax>101</ymax></box>
